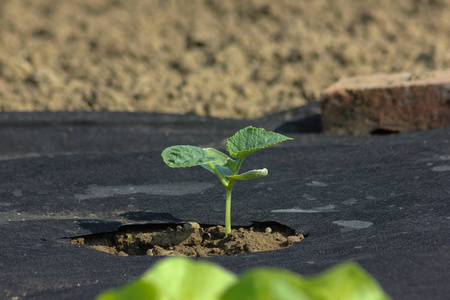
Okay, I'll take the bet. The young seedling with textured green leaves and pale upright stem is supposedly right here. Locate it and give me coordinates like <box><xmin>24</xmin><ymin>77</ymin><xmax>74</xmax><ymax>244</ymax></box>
<box><xmin>161</xmin><ymin>126</ymin><xmax>292</xmax><ymax>236</ymax></box>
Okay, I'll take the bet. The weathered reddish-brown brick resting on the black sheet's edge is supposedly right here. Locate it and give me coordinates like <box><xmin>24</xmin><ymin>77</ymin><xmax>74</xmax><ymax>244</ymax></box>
<box><xmin>321</xmin><ymin>70</ymin><xmax>450</xmax><ymax>135</ymax></box>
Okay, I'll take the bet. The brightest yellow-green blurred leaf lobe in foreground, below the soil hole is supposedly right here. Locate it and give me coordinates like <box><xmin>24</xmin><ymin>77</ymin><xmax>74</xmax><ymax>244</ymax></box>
<box><xmin>142</xmin><ymin>257</ymin><xmax>237</xmax><ymax>300</ymax></box>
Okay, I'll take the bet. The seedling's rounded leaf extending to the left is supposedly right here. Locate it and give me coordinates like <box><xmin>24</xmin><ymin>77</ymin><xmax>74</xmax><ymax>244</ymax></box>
<box><xmin>161</xmin><ymin>145</ymin><xmax>230</xmax><ymax>168</ymax></box>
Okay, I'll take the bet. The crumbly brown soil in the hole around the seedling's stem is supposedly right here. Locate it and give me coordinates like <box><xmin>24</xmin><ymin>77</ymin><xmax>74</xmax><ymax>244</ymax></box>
<box><xmin>71</xmin><ymin>222</ymin><xmax>304</xmax><ymax>257</ymax></box>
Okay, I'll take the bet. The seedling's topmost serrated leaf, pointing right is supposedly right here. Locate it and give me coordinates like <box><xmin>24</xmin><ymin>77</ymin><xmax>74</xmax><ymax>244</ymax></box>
<box><xmin>227</xmin><ymin>126</ymin><xmax>292</xmax><ymax>158</ymax></box>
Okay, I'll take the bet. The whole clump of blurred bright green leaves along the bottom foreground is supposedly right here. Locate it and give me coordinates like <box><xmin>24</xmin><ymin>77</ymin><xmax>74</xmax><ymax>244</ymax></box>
<box><xmin>96</xmin><ymin>257</ymin><xmax>391</xmax><ymax>300</ymax></box>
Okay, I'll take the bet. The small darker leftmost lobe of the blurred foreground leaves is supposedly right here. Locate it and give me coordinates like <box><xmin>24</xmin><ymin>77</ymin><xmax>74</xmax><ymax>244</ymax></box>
<box><xmin>96</xmin><ymin>279</ymin><xmax>161</xmax><ymax>300</ymax></box>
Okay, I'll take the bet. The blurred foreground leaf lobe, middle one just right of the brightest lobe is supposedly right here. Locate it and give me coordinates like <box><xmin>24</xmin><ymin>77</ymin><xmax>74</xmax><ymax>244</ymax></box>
<box><xmin>220</xmin><ymin>268</ymin><xmax>310</xmax><ymax>300</ymax></box>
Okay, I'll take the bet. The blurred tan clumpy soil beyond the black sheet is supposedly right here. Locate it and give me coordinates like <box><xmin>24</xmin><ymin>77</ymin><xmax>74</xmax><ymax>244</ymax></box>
<box><xmin>0</xmin><ymin>0</ymin><xmax>450</xmax><ymax>118</ymax></box>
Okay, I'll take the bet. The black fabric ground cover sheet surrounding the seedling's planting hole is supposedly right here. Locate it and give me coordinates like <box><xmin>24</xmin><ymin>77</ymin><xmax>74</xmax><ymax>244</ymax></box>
<box><xmin>0</xmin><ymin>105</ymin><xmax>450</xmax><ymax>300</ymax></box>
